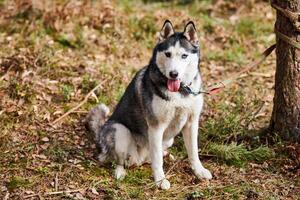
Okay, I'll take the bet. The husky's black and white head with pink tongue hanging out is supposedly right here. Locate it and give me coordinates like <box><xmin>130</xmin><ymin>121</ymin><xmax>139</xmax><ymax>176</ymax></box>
<box><xmin>153</xmin><ymin>20</ymin><xmax>200</xmax><ymax>92</ymax></box>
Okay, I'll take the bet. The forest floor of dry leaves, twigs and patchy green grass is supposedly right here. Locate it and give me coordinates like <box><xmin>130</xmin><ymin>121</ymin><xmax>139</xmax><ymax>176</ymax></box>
<box><xmin>0</xmin><ymin>0</ymin><xmax>300</xmax><ymax>199</ymax></box>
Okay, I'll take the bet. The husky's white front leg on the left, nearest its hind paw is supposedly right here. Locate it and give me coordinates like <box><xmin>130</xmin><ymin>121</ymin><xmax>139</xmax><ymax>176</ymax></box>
<box><xmin>148</xmin><ymin>126</ymin><xmax>170</xmax><ymax>190</ymax></box>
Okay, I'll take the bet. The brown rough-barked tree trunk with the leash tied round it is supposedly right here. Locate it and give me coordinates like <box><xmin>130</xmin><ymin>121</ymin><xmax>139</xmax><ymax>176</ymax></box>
<box><xmin>270</xmin><ymin>0</ymin><xmax>300</xmax><ymax>142</ymax></box>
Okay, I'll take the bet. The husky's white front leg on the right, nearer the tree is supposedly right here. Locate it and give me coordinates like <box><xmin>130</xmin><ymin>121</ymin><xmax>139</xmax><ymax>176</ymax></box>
<box><xmin>182</xmin><ymin>115</ymin><xmax>212</xmax><ymax>179</ymax></box>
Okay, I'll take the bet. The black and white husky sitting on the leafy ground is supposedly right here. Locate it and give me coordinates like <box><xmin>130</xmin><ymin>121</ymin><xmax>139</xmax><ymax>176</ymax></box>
<box><xmin>86</xmin><ymin>20</ymin><xmax>212</xmax><ymax>189</ymax></box>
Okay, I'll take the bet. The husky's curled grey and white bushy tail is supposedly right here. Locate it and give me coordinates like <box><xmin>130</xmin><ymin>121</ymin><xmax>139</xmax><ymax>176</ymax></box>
<box><xmin>84</xmin><ymin>104</ymin><xmax>109</xmax><ymax>144</ymax></box>
